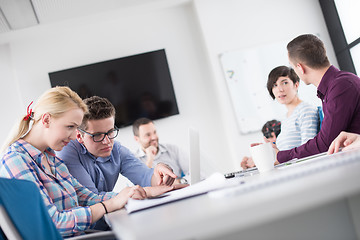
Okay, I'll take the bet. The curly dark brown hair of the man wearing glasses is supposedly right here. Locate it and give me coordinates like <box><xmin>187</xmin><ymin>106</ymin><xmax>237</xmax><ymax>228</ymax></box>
<box><xmin>80</xmin><ymin>96</ymin><xmax>116</xmax><ymax>130</ymax></box>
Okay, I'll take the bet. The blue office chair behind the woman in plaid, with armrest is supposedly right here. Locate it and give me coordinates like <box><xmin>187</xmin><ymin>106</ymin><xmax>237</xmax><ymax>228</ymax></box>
<box><xmin>0</xmin><ymin>178</ymin><xmax>115</xmax><ymax>240</ymax></box>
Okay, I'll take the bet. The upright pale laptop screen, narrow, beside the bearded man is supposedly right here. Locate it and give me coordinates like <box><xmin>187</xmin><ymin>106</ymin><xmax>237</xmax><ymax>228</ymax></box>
<box><xmin>189</xmin><ymin>128</ymin><xmax>200</xmax><ymax>185</ymax></box>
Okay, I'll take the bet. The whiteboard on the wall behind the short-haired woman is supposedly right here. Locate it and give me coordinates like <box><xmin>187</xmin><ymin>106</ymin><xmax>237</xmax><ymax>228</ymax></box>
<box><xmin>220</xmin><ymin>42</ymin><xmax>289</xmax><ymax>134</ymax></box>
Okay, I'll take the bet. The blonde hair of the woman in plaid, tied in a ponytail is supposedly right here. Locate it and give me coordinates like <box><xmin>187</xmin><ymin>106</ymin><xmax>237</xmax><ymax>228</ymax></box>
<box><xmin>1</xmin><ymin>86</ymin><xmax>88</xmax><ymax>151</ymax></box>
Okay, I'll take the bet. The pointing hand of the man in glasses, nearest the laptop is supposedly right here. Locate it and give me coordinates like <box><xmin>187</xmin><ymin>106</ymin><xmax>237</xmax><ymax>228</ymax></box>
<box><xmin>151</xmin><ymin>163</ymin><xmax>177</xmax><ymax>186</ymax></box>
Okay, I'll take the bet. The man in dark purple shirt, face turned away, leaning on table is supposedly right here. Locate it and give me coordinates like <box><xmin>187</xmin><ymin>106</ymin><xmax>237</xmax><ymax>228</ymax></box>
<box><xmin>241</xmin><ymin>34</ymin><xmax>360</xmax><ymax>168</ymax></box>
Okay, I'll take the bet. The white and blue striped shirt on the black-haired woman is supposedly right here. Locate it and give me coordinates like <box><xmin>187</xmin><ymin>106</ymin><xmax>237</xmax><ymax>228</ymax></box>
<box><xmin>276</xmin><ymin>102</ymin><xmax>319</xmax><ymax>151</ymax></box>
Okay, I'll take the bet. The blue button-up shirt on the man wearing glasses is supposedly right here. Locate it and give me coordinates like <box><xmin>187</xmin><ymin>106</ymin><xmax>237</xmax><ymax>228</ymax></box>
<box><xmin>56</xmin><ymin>141</ymin><xmax>154</xmax><ymax>193</ymax></box>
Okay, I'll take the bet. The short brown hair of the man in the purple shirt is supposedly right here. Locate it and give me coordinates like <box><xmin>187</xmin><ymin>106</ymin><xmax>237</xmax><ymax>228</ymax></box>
<box><xmin>287</xmin><ymin>34</ymin><xmax>330</xmax><ymax>69</ymax></box>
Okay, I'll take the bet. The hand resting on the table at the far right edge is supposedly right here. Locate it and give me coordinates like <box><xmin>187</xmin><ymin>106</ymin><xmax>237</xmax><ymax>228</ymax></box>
<box><xmin>328</xmin><ymin>132</ymin><xmax>360</xmax><ymax>154</ymax></box>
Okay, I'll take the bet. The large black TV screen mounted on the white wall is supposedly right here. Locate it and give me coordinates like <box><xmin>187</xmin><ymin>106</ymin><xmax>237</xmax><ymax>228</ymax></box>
<box><xmin>49</xmin><ymin>49</ymin><xmax>179</xmax><ymax>127</ymax></box>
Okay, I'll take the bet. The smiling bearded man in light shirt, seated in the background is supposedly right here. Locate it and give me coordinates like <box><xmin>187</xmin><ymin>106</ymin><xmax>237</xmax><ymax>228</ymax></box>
<box><xmin>133</xmin><ymin>118</ymin><xmax>189</xmax><ymax>183</ymax></box>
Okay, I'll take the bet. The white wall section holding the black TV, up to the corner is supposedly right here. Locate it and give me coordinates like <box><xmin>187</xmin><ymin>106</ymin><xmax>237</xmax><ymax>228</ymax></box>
<box><xmin>0</xmin><ymin>1</ymin><xmax>230</xmax><ymax>172</ymax></box>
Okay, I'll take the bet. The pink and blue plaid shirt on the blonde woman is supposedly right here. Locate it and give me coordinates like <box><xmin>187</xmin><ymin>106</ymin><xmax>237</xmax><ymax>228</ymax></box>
<box><xmin>0</xmin><ymin>140</ymin><xmax>116</xmax><ymax>236</ymax></box>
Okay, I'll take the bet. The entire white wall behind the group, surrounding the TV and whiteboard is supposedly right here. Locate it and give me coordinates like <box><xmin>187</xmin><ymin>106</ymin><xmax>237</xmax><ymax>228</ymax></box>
<box><xmin>0</xmin><ymin>0</ymin><xmax>335</xmax><ymax>174</ymax></box>
